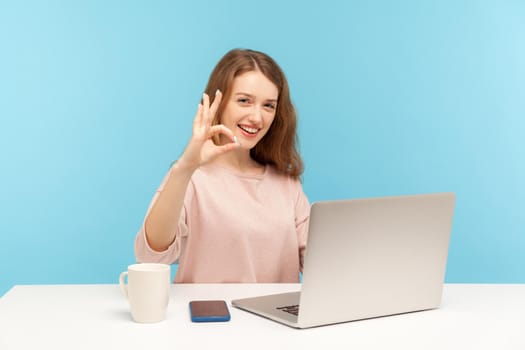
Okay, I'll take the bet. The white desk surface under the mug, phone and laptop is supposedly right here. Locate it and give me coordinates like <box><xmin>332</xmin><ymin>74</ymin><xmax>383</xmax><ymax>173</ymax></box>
<box><xmin>0</xmin><ymin>284</ymin><xmax>525</xmax><ymax>350</ymax></box>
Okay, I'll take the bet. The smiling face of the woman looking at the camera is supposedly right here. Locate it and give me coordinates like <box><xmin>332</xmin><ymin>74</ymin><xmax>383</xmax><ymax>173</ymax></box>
<box><xmin>220</xmin><ymin>71</ymin><xmax>279</xmax><ymax>149</ymax></box>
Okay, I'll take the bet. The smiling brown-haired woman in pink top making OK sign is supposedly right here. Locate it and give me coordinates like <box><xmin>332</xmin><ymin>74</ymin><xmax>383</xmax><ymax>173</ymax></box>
<box><xmin>135</xmin><ymin>49</ymin><xmax>310</xmax><ymax>283</ymax></box>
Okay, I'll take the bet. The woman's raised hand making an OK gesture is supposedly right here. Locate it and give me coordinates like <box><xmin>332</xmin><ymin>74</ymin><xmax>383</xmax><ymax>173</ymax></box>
<box><xmin>179</xmin><ymin>90</ymin><xmax>239</xmax><ymax>169</ymax></box>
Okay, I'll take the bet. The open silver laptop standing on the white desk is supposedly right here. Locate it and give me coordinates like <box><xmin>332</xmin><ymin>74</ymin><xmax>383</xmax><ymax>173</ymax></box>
<box><xmin>232</xmin><ymin>193</ymin><xmax>455</xmax><ymax>328</ymax></box>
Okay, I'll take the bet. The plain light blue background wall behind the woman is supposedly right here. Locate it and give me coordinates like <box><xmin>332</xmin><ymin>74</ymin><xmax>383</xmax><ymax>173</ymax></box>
<box><xmin>0</xmin><ymin>0</ymin><xmax>525</xmax><ymax>295</ymax></box>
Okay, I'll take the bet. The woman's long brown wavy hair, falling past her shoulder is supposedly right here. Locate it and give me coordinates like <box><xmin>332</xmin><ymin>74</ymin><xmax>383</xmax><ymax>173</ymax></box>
<box><xmin>205</xmin><ymin>49</ymin><xmax>304</xmax><ymax>178</ymax></box>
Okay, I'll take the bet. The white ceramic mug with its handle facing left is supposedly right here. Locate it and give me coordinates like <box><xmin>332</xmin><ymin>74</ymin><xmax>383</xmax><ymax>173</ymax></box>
<box><xmin>119</xmin><ymin>263</ymin><xmax>170</xmax><ymax>323</ymax></box>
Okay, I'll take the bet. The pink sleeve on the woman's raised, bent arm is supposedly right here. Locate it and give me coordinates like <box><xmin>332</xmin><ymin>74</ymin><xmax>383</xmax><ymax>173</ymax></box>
<box><xmin>135</xmin><ymin>172</ymin><xmax>193</xmax><ymax>264</ymax></box>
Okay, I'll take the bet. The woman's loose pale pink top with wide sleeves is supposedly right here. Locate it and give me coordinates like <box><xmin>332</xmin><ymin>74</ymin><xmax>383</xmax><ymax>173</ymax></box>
<box><xmin>135</xmin><ymin>165</ymin><xmax>310</xmax><ymax>283</ymax></box>
